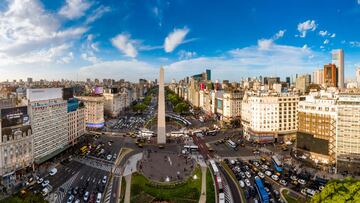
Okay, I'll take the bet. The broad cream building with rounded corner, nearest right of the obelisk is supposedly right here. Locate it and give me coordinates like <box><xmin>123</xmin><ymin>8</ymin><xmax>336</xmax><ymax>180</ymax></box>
<box><xmin>241</xmin><ymin>93</ymin><xmax>299</xmax><ymax>143</ymax></box>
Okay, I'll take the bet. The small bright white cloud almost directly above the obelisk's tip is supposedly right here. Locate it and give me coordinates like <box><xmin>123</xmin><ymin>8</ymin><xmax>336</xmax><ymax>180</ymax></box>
<box><xmin>164</xmin><ymin>27</ymin><xmax>190</xmax><ymax>53</ymax></box>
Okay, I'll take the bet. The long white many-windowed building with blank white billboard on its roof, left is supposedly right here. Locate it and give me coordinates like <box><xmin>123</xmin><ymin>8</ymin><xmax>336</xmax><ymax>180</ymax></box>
<box><xmin>27</xmin><ymin>88</ymin><xmax>68</xmax><ymax>164</ymax></box>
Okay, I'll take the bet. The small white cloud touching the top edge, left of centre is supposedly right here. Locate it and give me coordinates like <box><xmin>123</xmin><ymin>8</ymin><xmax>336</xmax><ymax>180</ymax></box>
<box><xmin>59</xmin><ymin>0</ymin><xmax>91</xmax><ymax>19</ymax></box>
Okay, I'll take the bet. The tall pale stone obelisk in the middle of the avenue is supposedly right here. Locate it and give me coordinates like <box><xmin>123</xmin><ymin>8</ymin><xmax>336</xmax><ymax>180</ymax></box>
<box><xmin>157</xmin><ymin>67</ymin><xmax>166</xmax><ymax>144</ymax></box>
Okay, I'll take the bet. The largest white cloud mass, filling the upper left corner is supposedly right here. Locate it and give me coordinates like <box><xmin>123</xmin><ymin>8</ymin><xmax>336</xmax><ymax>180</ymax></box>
<box><xmin>0</xmin><ymin>0</ymin><xmax>87</xmax><ymax>65</ymax></box>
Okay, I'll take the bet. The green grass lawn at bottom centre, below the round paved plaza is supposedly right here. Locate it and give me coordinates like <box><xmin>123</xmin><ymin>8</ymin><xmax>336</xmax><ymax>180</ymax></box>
<box><xmin>131</xmin><ymin>167</ymin><xmax>201</xmax><ymax>203</ymax></box>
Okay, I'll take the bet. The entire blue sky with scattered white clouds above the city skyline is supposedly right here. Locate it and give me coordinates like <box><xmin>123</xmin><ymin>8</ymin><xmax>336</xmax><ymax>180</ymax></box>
<box><xmin>0</xmin><ymin>0</ymin><xmax>360</xmax><ymax>81</ymax></box>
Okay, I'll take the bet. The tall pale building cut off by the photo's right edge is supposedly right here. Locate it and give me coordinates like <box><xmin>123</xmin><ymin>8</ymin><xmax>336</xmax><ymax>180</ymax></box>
<box><xmin>336</xmin><ymin>93</ymin><xmax>360</xmax><ymax>175</ymax></box>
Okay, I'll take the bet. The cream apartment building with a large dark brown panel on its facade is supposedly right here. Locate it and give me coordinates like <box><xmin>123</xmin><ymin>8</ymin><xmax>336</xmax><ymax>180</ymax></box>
<box><xmin>296</xmin><ymin>92</ymin><xmax>337</xmax><ymax>164</ymax></box>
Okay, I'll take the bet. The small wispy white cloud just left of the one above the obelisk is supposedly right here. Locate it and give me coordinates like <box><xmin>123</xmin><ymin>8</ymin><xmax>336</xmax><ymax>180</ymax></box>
<box><xmin>111</xmin><ymin>33</ymin><xmax>138</xmax><ymax>58</ymax></box>
